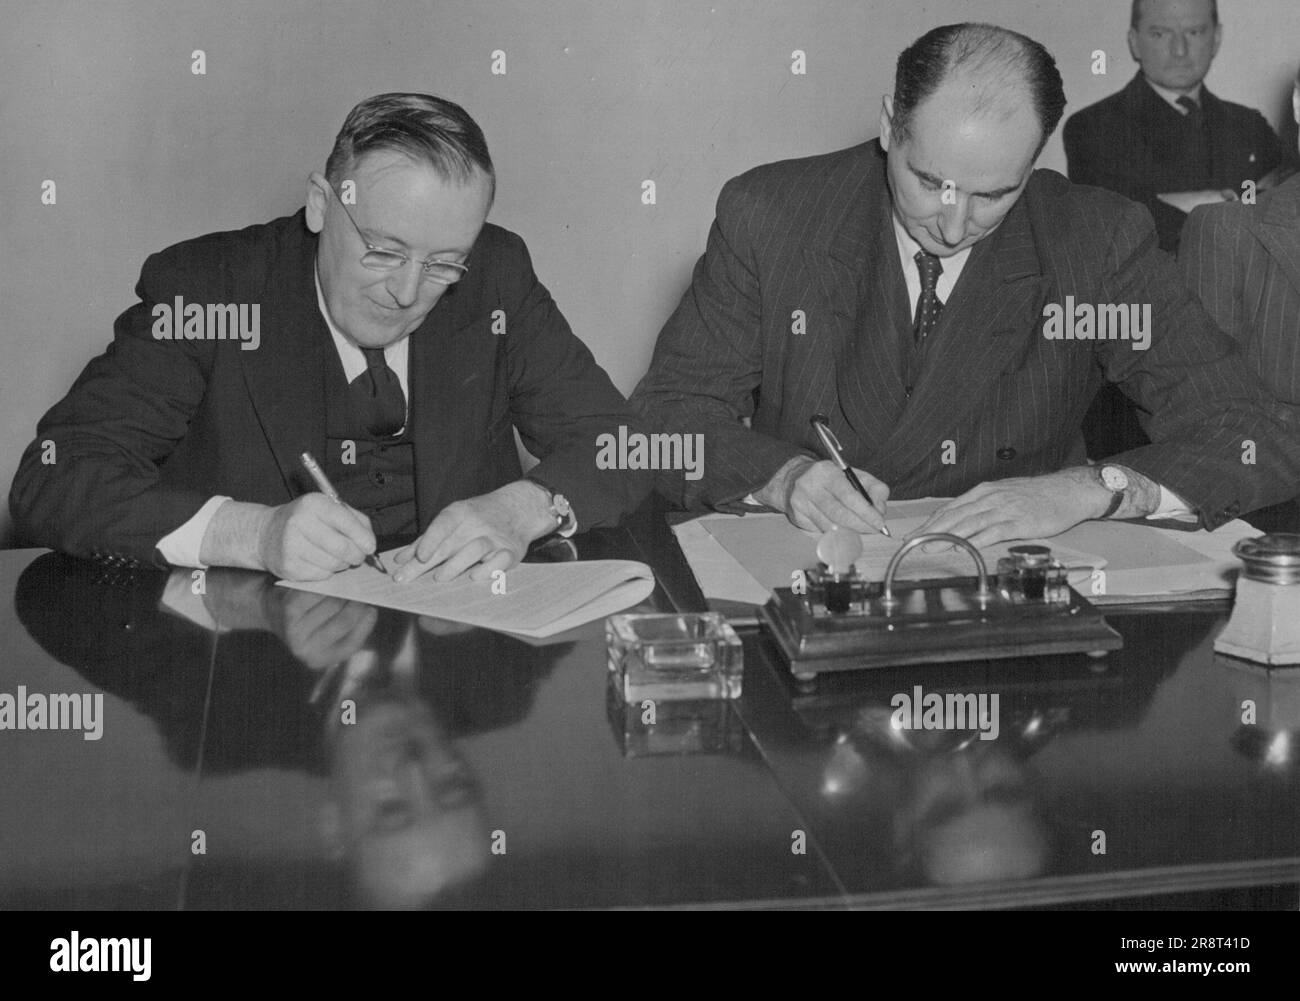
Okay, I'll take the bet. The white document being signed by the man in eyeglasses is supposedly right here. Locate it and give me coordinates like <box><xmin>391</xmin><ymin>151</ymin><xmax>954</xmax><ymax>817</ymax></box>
<box><xmin>278</xmin><ymin>550</ymin><xmax>654</xmax><ymax>638</ymax></box>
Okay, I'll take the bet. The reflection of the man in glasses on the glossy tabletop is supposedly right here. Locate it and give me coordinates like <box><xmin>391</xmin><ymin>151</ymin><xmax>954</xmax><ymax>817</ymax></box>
<box><xmin>14</xmin><ymin>554</ymin><xmax>571</xmax><ymax>907</ymax></box>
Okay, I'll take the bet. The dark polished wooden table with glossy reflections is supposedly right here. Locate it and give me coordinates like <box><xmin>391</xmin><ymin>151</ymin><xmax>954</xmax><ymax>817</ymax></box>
<box><xmin>0</xmin><ymin>511</ymin><xmax>1300</xmax><ymax>909</ymax></box>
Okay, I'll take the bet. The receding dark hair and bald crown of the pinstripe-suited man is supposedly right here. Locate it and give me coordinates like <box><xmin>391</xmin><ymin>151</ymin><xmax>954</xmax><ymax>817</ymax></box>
<box><xmin>891</xmin><ymin>23</ymin><xmax>1065</xmax><ymax>151</ymax></box>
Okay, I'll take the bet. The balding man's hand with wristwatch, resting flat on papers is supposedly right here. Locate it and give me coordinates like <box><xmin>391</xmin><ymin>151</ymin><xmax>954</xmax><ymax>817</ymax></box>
<box><xmin>911</xmin><ymin>465</ymin><xmax>1160</xmax><ymax>546</ymax></box>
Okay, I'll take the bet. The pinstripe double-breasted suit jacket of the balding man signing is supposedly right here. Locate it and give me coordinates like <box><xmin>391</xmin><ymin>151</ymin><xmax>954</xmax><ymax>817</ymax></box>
<box><xmin>632</xmin><ymin>142</ymin><xmax>1300</xmax><ymax>528</ymax></box>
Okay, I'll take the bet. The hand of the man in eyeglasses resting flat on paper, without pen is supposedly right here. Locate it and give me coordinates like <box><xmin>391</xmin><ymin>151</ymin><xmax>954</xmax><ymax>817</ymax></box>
<box><xmin>382</xmin><ymin>480</ymin><xmax>555</xmax><ymax>582</ymax></box>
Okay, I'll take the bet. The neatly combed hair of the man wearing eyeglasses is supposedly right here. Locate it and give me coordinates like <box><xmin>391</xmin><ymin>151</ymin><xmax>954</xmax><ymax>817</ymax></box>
<box><xmin>325</xmin><ymin>94</ymin><xmax>497</xmax><ymax>195</ymax></box>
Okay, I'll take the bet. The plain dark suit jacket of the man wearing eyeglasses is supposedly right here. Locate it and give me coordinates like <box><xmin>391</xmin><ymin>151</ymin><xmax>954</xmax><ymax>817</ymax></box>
<box><xmin>9</xmin><ymin>211</ymin><xmax>651</xmax><ymax>562</ymax></box>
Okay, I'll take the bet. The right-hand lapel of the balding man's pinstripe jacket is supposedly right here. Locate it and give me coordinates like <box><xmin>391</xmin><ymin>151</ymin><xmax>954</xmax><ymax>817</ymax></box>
<box><xmin>885</xmin><ymin>195</ymin><xmax>1047</xmax><ymax>481</ymax></box>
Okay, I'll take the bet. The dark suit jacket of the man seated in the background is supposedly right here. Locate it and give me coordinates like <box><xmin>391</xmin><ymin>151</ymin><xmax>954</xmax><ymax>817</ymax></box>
<box><xmin>1063</xmin><ymin>70</ymin><xmax>1294</xmax><ymax>252</ymax></box>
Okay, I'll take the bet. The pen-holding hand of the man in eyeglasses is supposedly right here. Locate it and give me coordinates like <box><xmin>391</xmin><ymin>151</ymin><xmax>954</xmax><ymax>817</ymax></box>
<box><xmin>199</xmin><ymin>494</ymin><xmax>374</xmax><ymax>580</ymax></box>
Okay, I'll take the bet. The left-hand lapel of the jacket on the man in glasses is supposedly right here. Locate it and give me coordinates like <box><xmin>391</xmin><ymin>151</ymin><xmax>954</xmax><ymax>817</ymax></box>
<box><xmin>238</xmin><ymin>220</ymin><xmax>333</xmax><ymax>498</ymax></box>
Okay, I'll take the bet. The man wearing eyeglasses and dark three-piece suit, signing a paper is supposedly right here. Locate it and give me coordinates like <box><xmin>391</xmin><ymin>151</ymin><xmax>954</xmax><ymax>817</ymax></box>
<box><xmin>10</xmin><ymin>94</ymin><xmax>650</xmax><ymax>581</ymax></box>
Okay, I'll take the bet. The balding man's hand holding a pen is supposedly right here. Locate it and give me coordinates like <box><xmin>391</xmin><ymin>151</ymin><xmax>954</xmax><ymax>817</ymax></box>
<box><xmin>754</xmin><ymin>456</ymin><xmax>889</xmax><ymax>532</ymax></box>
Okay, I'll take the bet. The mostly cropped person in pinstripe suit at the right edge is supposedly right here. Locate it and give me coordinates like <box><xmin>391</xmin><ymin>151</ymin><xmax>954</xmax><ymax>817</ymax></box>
<box><xmin>1179</xmin><ymin>74</ymin><xmax>1300</xmax><ymax>532</ymax></box>
